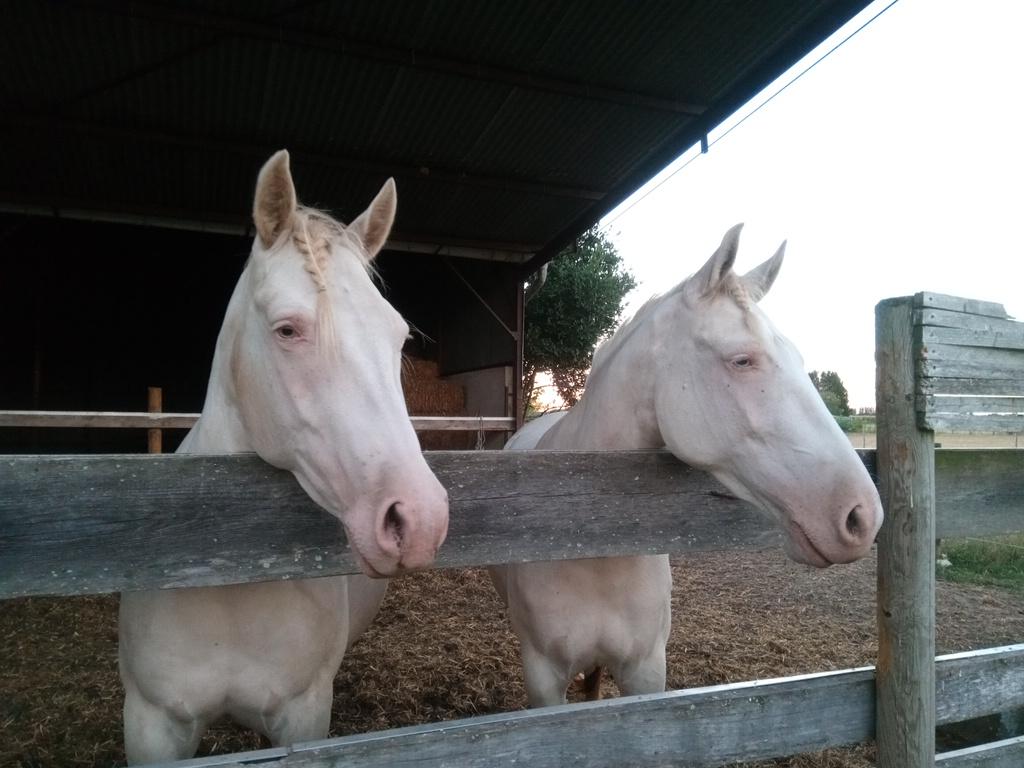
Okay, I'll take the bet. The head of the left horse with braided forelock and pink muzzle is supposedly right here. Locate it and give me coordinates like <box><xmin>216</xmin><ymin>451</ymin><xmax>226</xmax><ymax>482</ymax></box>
<box><xmin>224</xmin><ymin>151</ymin><xmax>447</xmax><ymax>575</ymax></box>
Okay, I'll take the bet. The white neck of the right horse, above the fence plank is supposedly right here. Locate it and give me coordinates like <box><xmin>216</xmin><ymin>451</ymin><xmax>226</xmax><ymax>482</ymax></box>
<box><xmin>538</xmin><ymin>307</ymin><xmax>665</xmax><ymax>451</ymax></box>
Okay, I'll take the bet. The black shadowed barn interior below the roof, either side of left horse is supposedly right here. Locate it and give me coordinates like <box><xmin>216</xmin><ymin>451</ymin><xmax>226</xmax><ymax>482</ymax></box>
<box><xmin>0</xmin><ymin>215</ymin><xmax>516</xmax><ymax>453</ymax></box>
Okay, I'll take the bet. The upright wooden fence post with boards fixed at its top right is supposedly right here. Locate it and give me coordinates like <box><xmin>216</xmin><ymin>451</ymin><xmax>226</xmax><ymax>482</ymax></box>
<box><xmin>876</xmin><ymin>293</ymin><xmax>1024</xmax><ymax>768</ymax></box>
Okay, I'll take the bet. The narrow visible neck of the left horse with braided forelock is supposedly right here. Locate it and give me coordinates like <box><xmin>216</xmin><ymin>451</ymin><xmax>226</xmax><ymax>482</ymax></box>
<box><xmin>178</xmin><ymin>265</ymin><xmax>253</xmax><ymax>454</ymax></box>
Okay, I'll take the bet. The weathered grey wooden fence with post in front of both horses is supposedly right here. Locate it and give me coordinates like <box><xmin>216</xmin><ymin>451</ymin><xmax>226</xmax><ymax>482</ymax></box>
<box><xmin>0</xmin><ymin>295</ymin><xmax>1024</xmax><ymax>768</ymax></box>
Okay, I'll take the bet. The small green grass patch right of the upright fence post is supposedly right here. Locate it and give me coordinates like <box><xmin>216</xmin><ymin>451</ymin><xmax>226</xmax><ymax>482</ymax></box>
<box><xmin>938</xmin><ymin>534</ymin><xmax>1024</xmax><ymax>594</ymax></box>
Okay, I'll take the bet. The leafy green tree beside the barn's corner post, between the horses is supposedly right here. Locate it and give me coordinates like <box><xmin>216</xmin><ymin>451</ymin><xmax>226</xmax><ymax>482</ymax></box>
<box><xmin>523</xmin><ymin>227</ymin><xmax>636</xmax><ymax>417</ymax></box>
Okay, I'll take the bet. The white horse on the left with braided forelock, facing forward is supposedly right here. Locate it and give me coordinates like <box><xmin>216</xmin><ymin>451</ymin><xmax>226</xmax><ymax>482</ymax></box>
<box><xmin>120</xmin><ymin>151</ymin><xmax>447</xmax><ymax>763</ymax></box>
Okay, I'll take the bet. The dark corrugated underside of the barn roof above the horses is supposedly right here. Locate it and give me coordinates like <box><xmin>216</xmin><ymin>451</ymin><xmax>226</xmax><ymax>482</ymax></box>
<box><xmin>0</xmin><ymin>0</ymin><xmax>867</xmax><ymax>265</ymax></box>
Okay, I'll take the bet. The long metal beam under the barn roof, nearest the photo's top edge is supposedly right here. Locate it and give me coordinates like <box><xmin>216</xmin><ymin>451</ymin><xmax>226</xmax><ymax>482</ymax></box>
<box><xmin>79</xmin><ymin>0</ymin><xmax>707</xmax><ymax>116</ymax></box>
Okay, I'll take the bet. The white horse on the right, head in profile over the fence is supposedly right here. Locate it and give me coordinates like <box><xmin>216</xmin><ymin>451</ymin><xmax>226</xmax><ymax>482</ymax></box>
<box><xmin>490</xmin><ymin>226</ymin><xmax>882</xmax><ymax>707</ymax></box>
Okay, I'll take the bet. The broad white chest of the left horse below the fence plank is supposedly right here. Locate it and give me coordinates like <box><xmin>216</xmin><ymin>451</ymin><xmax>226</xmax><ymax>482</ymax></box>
<box><xmin>121</xmin><ymin>579</ymin><xmax>348</xmax><ymax>715</ymax></box>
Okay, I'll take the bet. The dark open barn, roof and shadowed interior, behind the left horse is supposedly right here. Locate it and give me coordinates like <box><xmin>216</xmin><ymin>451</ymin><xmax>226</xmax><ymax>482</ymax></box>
<box><xmin>0</xmin><ymin>0</ymin><xmax>866</xmax><ymax>453</ymax></box>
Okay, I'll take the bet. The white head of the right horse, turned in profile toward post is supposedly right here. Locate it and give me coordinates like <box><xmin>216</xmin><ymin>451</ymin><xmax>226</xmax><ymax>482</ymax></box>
<box><xmin>654</xmin><ymin>225</ymin><xmax>883</xmax><ymax>567</ymax></box>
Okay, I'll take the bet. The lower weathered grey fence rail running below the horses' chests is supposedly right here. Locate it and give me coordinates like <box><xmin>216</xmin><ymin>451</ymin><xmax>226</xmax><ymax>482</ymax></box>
<box><xmin>149</xmin><ymin>645</ymin><xmax>1024</xmax><ymax>768</ymax></box>
